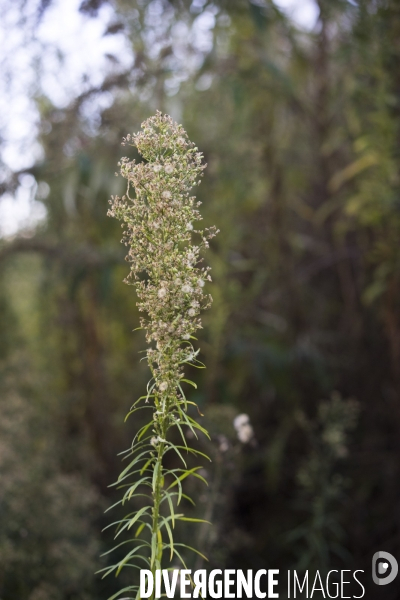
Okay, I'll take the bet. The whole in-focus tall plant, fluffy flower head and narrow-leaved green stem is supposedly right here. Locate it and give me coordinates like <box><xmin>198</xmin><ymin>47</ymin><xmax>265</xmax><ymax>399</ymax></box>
<box><xmin>100</xmin><ymin>112</ymin><xmax>217</xmax><ymax>600</ymax></box>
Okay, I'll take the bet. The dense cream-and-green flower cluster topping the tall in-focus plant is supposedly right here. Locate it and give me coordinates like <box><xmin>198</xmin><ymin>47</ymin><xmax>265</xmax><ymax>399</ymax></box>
<box><xmin>109</xmin><ymin>112</ymin><xmax>217</xmax><ymax>408</ymax></box>
